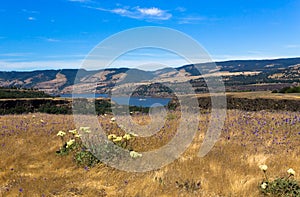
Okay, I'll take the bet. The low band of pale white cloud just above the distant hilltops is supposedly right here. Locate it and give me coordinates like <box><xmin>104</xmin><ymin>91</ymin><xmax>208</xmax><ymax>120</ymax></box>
<box><xmin>0</xmin><ymin>55</ymin><xmax>295</xmax><ymax>71</ymax></box>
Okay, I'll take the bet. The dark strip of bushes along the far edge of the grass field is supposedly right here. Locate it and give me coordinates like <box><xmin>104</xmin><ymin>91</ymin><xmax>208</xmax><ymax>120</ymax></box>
<box><xmin>0</xmin><ymin>96</ymin><xmax>300</xmax><ymax>115</ymax></box>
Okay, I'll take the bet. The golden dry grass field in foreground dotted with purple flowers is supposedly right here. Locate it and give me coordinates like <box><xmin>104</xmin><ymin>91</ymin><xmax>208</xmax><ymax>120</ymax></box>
<box><xmin>0</xmin><ymin>110</ymin><xmax>300</xmax><ymax>197</ymax></box>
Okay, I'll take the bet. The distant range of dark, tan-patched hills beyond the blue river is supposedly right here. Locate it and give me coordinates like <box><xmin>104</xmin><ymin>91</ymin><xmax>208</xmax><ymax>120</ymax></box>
<box><xmin>0</xmin><ymin>58</ymin><xmax>300</xmax><ymax>94</ymax></box>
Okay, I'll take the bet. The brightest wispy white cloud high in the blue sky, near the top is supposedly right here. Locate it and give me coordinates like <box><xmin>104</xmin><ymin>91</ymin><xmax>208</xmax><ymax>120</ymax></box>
<box><xmin>87</xmin><ymin>6</ymin><xmax>172</xmax><ymax>20</ymax></box>
